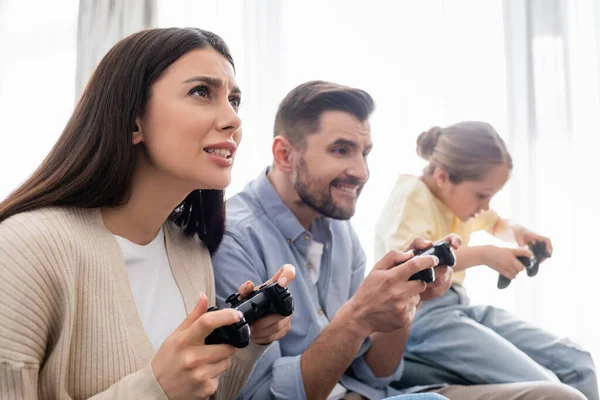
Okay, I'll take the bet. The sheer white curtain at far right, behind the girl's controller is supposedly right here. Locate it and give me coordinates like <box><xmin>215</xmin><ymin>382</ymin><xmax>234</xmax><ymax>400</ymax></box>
<box><xmin>478</xmin><ymin>0</ymin><xmax>600</xmax><ymax>362</ymax></box>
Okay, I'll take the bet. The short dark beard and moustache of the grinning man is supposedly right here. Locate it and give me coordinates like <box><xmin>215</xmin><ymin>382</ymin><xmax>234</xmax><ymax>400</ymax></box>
<box><xmin>294</xmin><ymin>158</ymin><xmax>362</xmax><ymax>220</ymax></box>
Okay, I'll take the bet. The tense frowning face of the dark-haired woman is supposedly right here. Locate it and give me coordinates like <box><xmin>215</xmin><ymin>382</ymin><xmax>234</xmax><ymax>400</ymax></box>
<box><xmin>133</xmin><ymin>48</ymin><xmax>242</xmax><ymax>191</ymax></box>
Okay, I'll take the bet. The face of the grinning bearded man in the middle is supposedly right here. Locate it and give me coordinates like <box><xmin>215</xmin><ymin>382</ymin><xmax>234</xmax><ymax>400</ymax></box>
<box><xmin>294</xmin><ymin>111</ymin><xmax>372</xmax><ymax>220</ymax></box>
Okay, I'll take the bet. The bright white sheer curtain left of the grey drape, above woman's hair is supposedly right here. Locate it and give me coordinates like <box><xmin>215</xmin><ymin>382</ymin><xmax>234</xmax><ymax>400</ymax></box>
<box><xmin>0</xmin><ymin>0</ymin><xmax>78</xmax><ymax>199</ymax></box>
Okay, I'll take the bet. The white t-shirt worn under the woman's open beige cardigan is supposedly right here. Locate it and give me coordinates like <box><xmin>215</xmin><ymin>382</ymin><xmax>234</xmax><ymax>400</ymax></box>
<box><xmin>115</xmin><ymin>228</ymin><xmax>186</xmax><ymax>350</ymax></box>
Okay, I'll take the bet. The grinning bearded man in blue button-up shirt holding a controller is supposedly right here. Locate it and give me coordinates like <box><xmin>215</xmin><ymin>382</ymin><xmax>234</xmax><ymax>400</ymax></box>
<box><xmin>213</xmin><ymin>81</ymin><xmax>581</xmax><ymax>400</ymax></box>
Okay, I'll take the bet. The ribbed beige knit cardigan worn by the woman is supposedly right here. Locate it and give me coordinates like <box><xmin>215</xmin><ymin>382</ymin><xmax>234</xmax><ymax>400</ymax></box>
<box><xmin>0</xmin><ymin>207</ymin><xmax>264</xmax><ymax>400</ymax></box>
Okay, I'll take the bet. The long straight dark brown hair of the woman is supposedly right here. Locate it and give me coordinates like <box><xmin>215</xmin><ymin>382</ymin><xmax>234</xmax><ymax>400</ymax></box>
<box><xmin>0</xmin><ymin>28</ymin><xmax>234</xmax><ymax>253</ymax></box>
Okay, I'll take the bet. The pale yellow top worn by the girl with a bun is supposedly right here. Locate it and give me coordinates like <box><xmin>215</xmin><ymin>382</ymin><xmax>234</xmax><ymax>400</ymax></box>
<box><xmin>375</xmin><ymin>175</ymin><xmax>500</xmax><ymax>285</ymax></box>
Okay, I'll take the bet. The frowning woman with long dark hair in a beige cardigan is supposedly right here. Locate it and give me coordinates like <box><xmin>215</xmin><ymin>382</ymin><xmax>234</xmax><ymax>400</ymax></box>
<box><xmin>0</xmin><ymin>29</ymin><xmax>294</xmax><ymax>400</ymax></box>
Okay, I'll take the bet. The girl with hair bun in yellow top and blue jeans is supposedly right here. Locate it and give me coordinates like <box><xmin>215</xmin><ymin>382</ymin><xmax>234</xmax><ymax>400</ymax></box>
<box><xmin>375</xmin><ymin>122</ymin><xmax>598</xmax><ymax>400</ymax></box>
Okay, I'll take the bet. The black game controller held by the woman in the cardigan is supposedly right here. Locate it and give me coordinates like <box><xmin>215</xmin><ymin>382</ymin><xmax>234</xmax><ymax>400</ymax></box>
<box><xmin>204</xmin><ymin>282</ymin><xmax>294</xmax><ymax>349</ymax></box>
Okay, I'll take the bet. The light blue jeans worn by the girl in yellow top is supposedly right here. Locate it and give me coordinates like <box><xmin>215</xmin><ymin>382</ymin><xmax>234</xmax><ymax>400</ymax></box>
<box><xmin>406</xmin><ymin>285</ymin><xmax>600</xmax><ymax>400</ymax></box>
